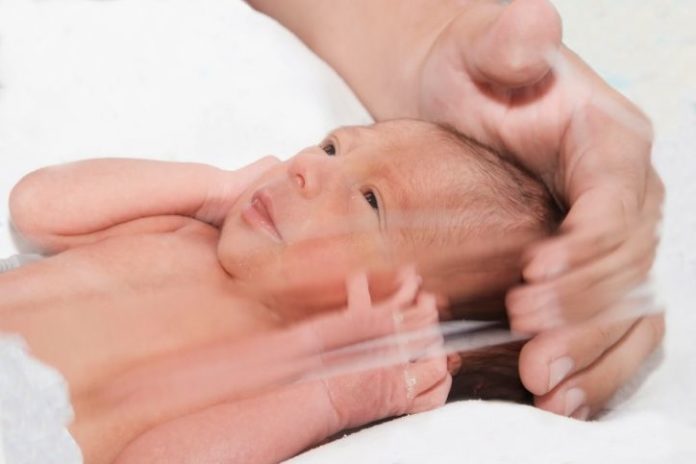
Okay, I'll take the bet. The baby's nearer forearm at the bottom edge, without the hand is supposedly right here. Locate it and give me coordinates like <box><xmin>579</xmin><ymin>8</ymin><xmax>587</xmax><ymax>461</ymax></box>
<box><xmin>114</xmin><ymin>382</ymin><xmax>340</xmax><ymax>464</ymax></box>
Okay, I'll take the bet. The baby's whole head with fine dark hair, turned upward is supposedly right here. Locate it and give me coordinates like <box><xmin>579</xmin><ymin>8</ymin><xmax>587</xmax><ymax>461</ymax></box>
<box><xmin>218</xmin><ymin>120</ymin><xmax>558</xmax><ymax>316</ymax></box>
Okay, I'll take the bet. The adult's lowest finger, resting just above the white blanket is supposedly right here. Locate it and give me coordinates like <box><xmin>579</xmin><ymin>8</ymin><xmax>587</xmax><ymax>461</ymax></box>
<box><xmin>535</xmin><ymin>315</ymin><xmax>664</xmax><ymax>420</ymax></box>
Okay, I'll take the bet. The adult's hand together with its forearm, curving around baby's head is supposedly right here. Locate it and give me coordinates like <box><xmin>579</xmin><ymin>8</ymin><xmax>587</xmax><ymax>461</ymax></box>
<box><xmin>250</xmin><ymin>0</ymin><xmax>664</xmax><ymax>417</ymax></box>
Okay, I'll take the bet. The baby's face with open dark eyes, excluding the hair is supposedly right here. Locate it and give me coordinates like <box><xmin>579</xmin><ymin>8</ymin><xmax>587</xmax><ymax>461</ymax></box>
<box><xmin>218</xmin><ymin>121</ymin><xmax>490</xmax><ymax>314</ymax></box>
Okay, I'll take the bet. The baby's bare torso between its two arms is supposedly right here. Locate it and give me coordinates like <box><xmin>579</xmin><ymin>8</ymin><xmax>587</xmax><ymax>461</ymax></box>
<box><xmin>0</xmin><ymin>221</ymin><xmax>277</xmax><ymax>406</ymax></box>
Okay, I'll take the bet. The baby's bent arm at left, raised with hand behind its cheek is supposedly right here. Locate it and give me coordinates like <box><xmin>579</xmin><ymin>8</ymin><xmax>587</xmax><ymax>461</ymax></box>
<box><xmin>10</xmin><ymin>158</ymin><xmax>277</xmax><ymax>252</ymax></box>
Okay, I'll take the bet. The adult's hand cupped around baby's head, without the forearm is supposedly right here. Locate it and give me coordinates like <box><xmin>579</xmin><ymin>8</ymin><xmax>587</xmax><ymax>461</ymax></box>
<box><xmin>410</xmin><ymin>0</ymin><xmax>664</xmax><ymax>419</ymax></box>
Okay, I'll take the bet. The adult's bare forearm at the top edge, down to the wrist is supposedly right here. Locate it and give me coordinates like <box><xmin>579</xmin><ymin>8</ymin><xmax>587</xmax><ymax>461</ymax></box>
<box><xmin>249</xmin><ymin>0</ymin><xmax>467</xmax><ymax>119</ymax></box>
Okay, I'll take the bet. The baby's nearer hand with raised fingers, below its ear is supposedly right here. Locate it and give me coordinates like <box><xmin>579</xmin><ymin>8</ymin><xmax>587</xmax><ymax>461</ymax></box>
<box><xmin>316</xmin><ymin>271</ymin><xmax>452</xmax><ymax>429</ymax></box>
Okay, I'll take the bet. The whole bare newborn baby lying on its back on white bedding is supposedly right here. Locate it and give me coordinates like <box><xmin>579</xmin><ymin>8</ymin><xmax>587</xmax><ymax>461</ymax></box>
<box><xmin>0</xmin><ymin>120</ymin><xmax>558</xmax><ymax>463</ymax></box>
